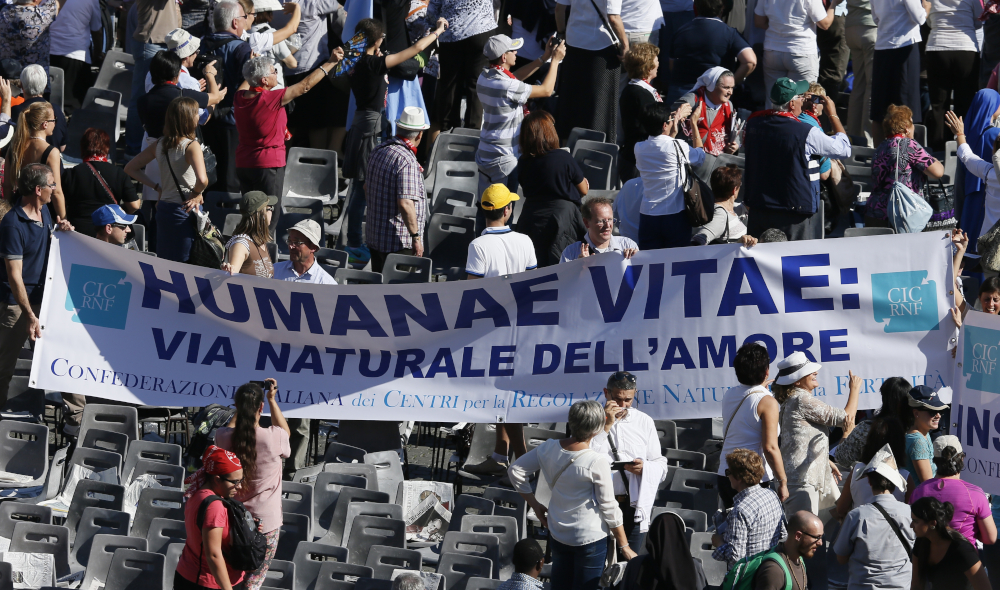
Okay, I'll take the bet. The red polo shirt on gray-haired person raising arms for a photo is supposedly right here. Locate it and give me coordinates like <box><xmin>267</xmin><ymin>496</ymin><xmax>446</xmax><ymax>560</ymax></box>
<box><xmin>233</xmin><ymin>88</ymin><xmax>288</xmax><ymax>168</ymax></box>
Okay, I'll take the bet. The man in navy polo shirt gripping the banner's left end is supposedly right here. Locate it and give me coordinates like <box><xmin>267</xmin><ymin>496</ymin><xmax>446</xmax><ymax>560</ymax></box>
<box><xmin>0</xmin><ymin>164</ymin><xmax>73</xmax><ymax>408</ymax></box>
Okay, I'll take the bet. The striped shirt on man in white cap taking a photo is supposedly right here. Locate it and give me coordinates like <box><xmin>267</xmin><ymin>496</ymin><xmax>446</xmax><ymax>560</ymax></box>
<box><xmin>476</xmin><ymin>67</ymin><xmax>531</xmax><ymax>175</ymax></box>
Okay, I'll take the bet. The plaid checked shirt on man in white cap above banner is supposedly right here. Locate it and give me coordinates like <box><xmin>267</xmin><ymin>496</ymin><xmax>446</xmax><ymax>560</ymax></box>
<box><xmin>365</xmin><ymin>137</ymin><xmax>427</xmax><ymax>252</ymax></box>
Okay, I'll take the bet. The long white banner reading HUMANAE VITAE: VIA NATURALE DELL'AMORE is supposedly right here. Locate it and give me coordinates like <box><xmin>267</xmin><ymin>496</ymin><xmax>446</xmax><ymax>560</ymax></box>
<box><xmin>31</xmin><ymin>232</ymin><xmax>956</xmax><ymax>422</ymax></box>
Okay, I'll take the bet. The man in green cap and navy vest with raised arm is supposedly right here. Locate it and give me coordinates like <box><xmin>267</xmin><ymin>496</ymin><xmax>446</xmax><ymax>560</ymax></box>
<box><xmin>743</xmin><ymin>78</ymin><xmax>851</xmax><ymax>241</ymax></box>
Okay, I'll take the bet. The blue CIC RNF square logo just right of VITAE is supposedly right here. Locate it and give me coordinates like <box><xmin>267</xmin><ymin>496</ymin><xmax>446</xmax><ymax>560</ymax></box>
<box><xmin>872</xmin><ymin>270</ymin><xmax>940</xmax><ymax>333</ymax></box>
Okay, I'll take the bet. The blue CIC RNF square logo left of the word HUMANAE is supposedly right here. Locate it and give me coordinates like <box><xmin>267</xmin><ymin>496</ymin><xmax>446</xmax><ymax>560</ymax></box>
<box><xmin>66</xmin><ymin>264</ymin><xmax>132</xmax><ymax>330</ymax></box>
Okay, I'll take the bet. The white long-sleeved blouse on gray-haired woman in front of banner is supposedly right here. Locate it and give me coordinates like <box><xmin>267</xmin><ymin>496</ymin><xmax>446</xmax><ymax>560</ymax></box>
<box><xmin>507</xmin><ymin>439</ymin><xmax>624</xmax><ymax>547</ymax></box>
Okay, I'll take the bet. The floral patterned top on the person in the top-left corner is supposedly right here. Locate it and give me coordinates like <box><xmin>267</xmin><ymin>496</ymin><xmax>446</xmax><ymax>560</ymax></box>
<box><xmin>0</xmin><ymin>0</ymin><xmax>59</xmax><ymax>72</ymax></box>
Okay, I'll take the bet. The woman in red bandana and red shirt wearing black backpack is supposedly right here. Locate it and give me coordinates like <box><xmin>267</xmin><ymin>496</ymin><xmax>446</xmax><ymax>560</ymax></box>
<box><xmin>174</xmin><ymin>445</ymin><xmax>244</xmax><ymax>590</ymax></box>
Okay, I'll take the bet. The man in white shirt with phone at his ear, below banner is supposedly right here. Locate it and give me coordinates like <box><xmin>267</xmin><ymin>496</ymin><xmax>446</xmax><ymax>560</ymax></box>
<box><xmin>590</xmin><ymin>372</ymin><xmax>667</xmax><ymax>551</ymax></box>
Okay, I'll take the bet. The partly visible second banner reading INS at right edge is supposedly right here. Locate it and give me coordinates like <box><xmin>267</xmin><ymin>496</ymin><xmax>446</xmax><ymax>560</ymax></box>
<box><xmin>951</xmin><ymin>311</ymin><xmax>1000</xmax><ymax>494</ymax></box>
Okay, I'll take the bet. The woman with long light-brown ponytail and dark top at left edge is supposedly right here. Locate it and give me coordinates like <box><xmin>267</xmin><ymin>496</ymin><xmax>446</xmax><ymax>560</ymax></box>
<box><xmin>3</xmin><ymin>102</ymin><xmax>66</xmax><ymax>219</ymax></box>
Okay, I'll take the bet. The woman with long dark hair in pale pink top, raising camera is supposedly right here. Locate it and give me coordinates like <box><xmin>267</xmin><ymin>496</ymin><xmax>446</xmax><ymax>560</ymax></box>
<box><xmin>215</xmin><ymin>379</ymin><xmax>291</xmax><ymax>590</ymax></box>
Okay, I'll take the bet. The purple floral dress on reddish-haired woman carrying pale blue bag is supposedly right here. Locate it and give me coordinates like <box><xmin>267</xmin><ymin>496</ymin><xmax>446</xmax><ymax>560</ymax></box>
<box><xmin>865</xmin><ymin>135</ymin><xmax>934</xmax><ymax>221</ymax></box>
